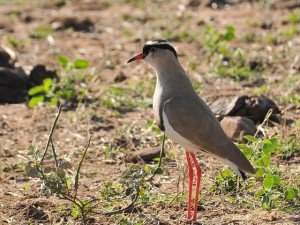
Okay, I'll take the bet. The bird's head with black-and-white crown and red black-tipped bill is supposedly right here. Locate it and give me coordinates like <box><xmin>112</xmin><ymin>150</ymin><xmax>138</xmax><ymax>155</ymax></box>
<box><xmin>127</xmin><ymin>40</ymin><xmax>177</xmax><ymax>67</ymax></box>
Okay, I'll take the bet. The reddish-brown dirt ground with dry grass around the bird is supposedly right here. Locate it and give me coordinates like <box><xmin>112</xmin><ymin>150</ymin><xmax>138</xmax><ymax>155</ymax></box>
<box><xmin>0</xmin><ymin>0</ymin><xmax>300</xmax><ymax>225</ymax></box>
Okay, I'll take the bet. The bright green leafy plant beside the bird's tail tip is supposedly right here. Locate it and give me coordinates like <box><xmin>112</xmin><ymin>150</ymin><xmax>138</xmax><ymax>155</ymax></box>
<box><xmin>239</xmin><ymin>136</ymin><xmax>300</xmax><ymax>210</ymax></box>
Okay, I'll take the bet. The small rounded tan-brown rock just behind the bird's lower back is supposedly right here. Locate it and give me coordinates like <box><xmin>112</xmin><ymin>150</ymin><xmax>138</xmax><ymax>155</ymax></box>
<box><xmin>221</xmin><ymin>116</ymin><xmax>256</xmax><ymax>141</ymax></box>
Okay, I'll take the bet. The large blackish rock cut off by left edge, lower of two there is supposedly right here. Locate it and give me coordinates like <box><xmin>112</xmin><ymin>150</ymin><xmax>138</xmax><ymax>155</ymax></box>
<box><xmin>0</xmin><ymin>67</ymin><xmax>28</xmax><ymax>103</ymax></box>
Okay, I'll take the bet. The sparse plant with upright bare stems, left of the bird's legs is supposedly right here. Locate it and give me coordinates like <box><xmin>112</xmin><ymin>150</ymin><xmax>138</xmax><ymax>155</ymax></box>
<box><xmin>25</xmin><ymin>107</ymin><xmax>165</xmax><ymax>224</ymax></box>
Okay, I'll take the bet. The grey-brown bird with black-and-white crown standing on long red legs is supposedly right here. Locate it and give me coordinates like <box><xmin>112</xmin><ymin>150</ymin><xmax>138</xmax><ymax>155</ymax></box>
<box><xmin>127</xmin><ymin>39</ymin><xmax>255</xmax><ymax>223</ymax></box>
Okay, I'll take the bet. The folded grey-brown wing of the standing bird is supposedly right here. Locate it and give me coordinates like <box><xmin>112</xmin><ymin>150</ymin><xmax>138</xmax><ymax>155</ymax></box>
<box><xmin>163</xmin><ymin>96</ymin><xmax>255</xmax><ymax>173</ymax></box>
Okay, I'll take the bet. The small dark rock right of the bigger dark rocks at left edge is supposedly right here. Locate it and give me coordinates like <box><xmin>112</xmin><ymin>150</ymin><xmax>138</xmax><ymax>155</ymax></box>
<box><xmin>29</xmin><ymin>65</ymin><xmax>58</xmax><ymax>87</ymax></box>
